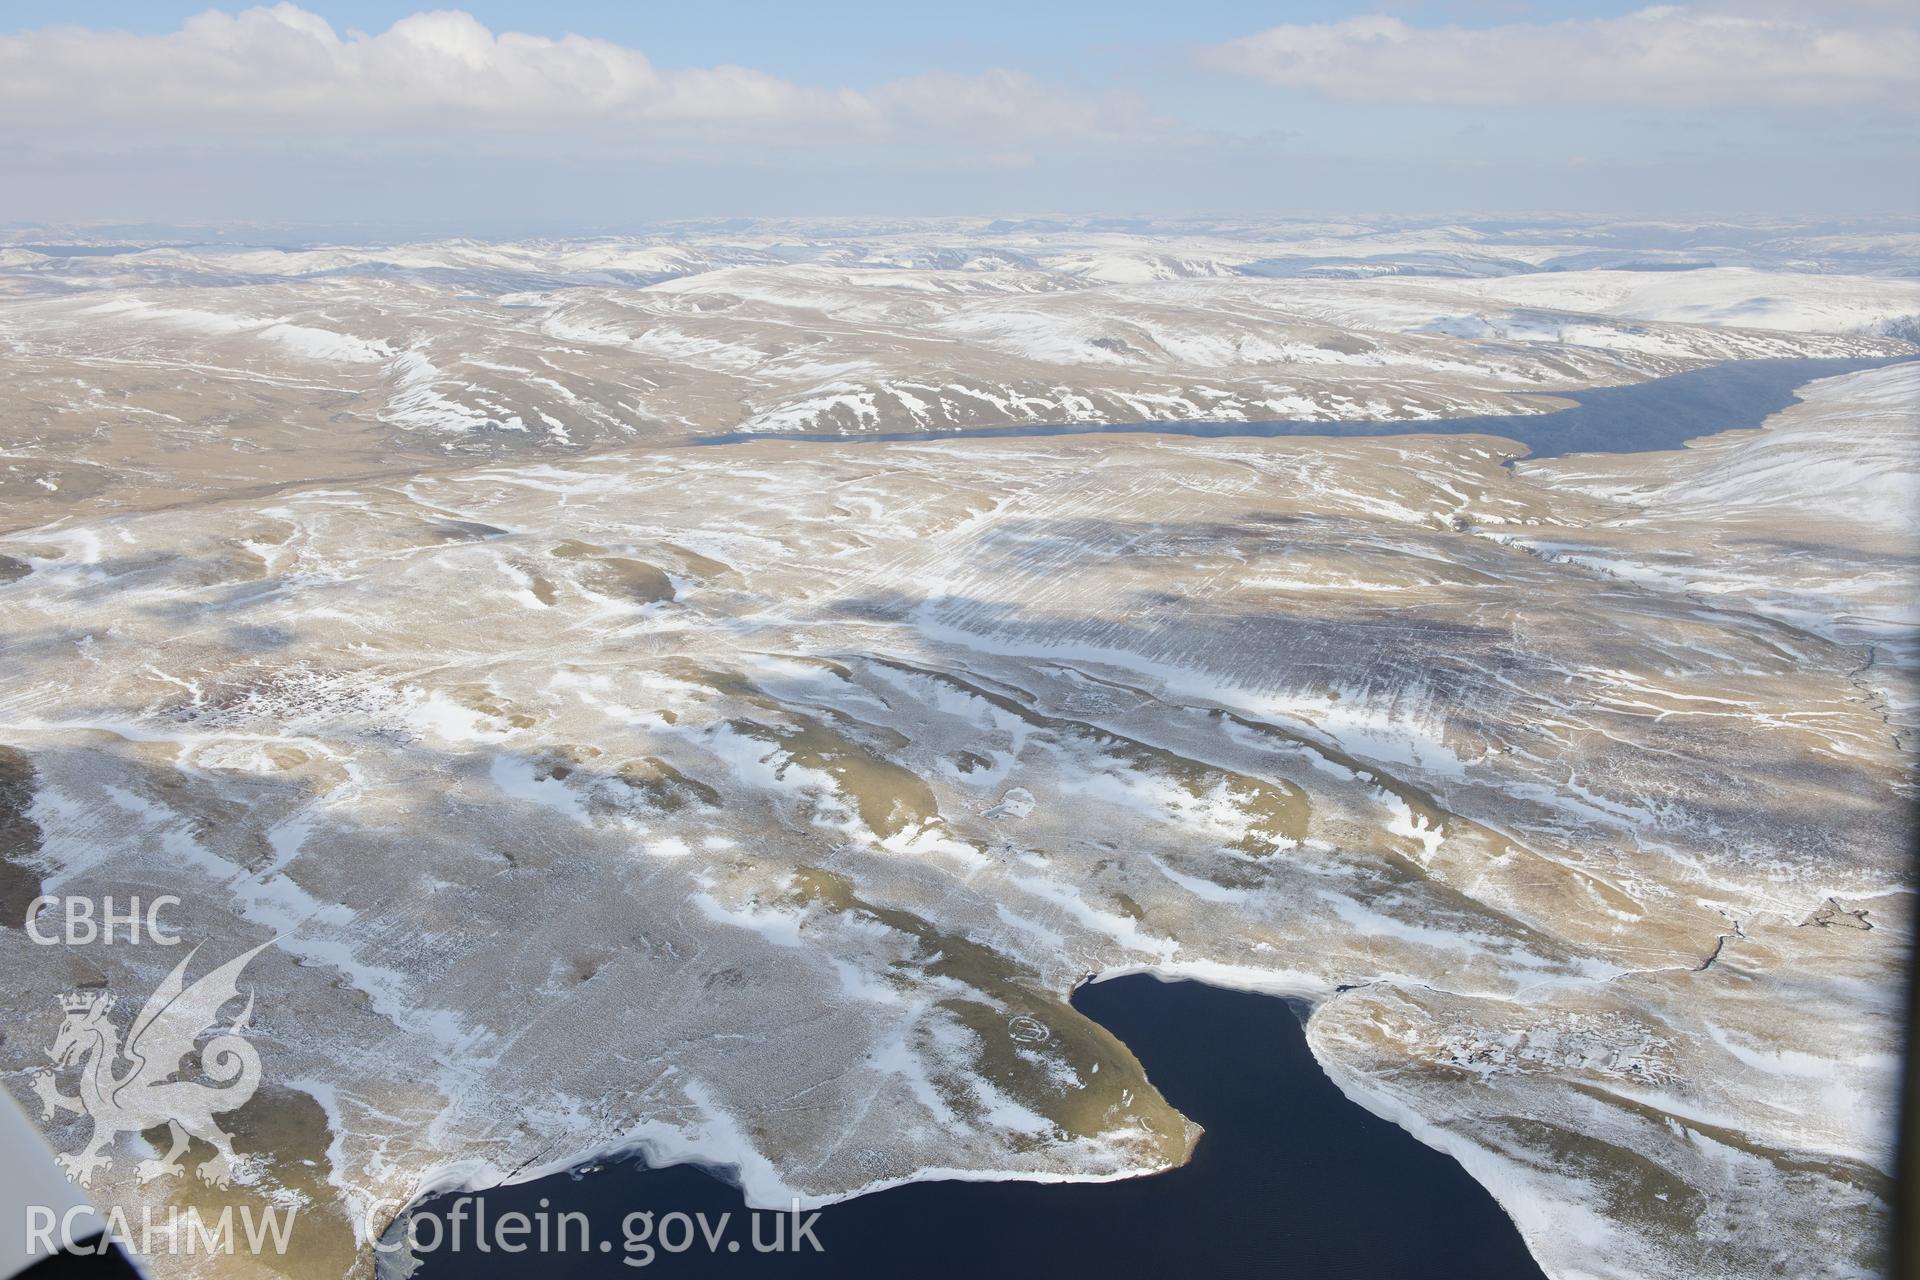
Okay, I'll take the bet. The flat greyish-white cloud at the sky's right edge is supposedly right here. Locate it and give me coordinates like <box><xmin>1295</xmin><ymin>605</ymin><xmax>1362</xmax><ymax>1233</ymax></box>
<box><xmin>1196</xmin><ymin>2</ymin><xmax>1920</xmax><ymax>107</ymax></box>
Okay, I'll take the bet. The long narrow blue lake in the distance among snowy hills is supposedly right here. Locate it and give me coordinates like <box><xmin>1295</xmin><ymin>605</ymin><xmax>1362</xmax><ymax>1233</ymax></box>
<box><xmin>695</xmin><ymin>355</ymin><xmax>1914</xmax><ymax>459</ymax></box>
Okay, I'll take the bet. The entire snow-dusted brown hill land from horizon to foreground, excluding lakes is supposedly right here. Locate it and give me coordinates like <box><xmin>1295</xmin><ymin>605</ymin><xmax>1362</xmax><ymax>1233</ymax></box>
<box><xmin>0</xmin><ymin>223</ymin><xmax>1920</xmax><ymax>1276</ymax></box>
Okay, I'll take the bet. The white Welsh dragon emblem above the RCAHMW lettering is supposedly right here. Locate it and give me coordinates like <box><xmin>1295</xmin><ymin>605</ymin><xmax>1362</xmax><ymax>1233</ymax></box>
<box><xmin>33</xmin><ymin>942</ymin><xmax>271</xmax><ymax>1186</ymax></box>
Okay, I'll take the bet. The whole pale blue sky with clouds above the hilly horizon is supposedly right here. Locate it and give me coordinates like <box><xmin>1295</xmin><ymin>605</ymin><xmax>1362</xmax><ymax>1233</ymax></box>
<box><xmin>0</xmin><ymin>0</ymin><xmax>1920</xmax><ymax>234</ymax></box>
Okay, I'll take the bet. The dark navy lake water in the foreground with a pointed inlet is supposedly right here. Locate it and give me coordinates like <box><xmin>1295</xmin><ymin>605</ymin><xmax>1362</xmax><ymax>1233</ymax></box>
<box><xmin>405</xmin><ymin>977</ymin><xmax>1542</xmax><ymax>1280</ymax></box>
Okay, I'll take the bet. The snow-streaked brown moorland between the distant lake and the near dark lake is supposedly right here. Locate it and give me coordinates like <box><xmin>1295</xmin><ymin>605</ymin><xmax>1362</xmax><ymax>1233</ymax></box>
<box><xmin>0</xmin><ymin>370</ymin><xmax>1912</xmax><ymax>1280</ymax></box>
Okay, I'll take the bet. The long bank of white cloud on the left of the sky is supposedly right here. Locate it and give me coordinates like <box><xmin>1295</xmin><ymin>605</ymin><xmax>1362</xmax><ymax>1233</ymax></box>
<box><xmin>0</xmin><ymin>4</ymin><xmax>1142</xmax><ymax>142</ymax></box>
